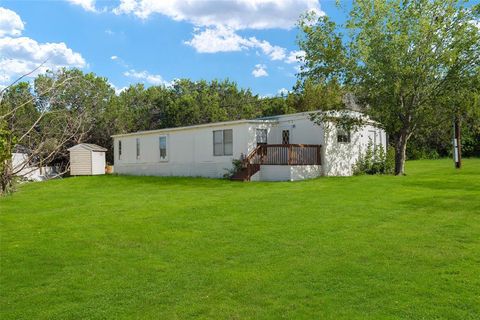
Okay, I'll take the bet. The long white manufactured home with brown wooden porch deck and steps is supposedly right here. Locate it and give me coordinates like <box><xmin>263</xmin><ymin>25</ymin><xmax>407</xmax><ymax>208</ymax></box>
<box><xmin>112</xmin><ymin>111</ymin><xmax>387</xmax><ymax>181</ymax></box>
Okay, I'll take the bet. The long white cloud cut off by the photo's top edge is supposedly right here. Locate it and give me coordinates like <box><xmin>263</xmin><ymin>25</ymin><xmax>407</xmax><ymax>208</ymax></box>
<box><xmin>114</xmin><ymin>0</ymin><xmax>323</xmax><ymax>30</ymax></box>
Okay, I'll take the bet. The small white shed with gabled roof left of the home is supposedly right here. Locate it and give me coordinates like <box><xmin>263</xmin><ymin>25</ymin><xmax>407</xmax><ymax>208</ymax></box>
<box><xmin>68</xmin><ymin>143</ymin><xmax>107</xmax><ymax>176</ymax></box>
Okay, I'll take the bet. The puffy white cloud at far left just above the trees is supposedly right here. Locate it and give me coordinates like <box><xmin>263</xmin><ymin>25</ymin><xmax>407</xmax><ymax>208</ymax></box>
<box><xmin>0</xmin><ymin>8</ymin><xmax>87</xmax><ymax>86</ymax></box>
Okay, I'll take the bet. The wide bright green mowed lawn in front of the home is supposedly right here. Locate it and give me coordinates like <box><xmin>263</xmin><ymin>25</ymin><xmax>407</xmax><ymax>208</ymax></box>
<box><xmin>0</xmin><ymin>159</ymin><xmax>480</xmax><ymax>319</ymax></box>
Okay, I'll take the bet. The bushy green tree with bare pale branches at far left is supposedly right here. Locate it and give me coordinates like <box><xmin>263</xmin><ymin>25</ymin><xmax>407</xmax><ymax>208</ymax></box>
<box><xmin>0</xmin><ymin>70</ymin><xmax>108</xmax><ymax>193</ymax></box>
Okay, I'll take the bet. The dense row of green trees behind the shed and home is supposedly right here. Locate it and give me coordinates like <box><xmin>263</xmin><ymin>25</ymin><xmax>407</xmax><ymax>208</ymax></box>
<box><xmin>0</xmin><ymin>69</ymin><xmax>302</xmax><ymax>174</ymax></box>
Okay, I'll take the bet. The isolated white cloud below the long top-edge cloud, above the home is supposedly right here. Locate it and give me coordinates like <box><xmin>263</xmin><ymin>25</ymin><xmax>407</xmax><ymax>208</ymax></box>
<box><xmin>185</xmin><ymin>26</ymin><xmax>287</xmax><ymax>60</ymax></box>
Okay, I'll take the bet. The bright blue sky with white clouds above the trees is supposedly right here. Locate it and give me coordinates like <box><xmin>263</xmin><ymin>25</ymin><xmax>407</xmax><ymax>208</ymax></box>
<box><xmin>0</xmin><ymin>0</ymin><xmax>352</xmax><ymax>95</ymax></box>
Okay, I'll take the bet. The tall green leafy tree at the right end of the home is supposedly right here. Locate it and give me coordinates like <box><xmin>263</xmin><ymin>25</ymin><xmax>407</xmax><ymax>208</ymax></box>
<box><xmin>299</xmin><ymin>0</ymin><xmax>480</xmax><ymax>174</ymax></box>
